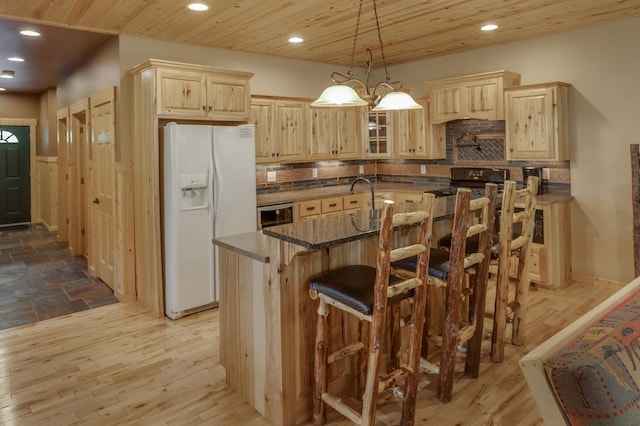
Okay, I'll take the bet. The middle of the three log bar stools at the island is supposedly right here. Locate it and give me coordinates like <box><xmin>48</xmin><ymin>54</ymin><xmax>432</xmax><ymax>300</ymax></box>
<box><xmin>393</xmin><ymin>183</ymin><xmax>498</xmax><ymax>402</ymax></box>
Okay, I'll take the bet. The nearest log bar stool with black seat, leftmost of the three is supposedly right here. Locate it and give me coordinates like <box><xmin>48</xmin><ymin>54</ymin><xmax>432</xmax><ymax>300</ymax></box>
<box><xmin>310</xmin><ymin>194</ymin><xmax>434</xmax><ymax>425</ymax></box>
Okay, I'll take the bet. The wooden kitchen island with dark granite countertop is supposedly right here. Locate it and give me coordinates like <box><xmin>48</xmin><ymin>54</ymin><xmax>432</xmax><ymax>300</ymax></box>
<box><xmin>215</xmin><ymin>205</ymin><xmax>430</xmax><ymax>425</ymax></box>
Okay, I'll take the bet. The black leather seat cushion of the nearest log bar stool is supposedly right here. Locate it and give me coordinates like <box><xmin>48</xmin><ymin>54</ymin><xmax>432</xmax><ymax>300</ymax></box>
<box><xmin>309</xmin><ymin>265</ymin><xmax>413</xmax><ymax>315</ymax></box>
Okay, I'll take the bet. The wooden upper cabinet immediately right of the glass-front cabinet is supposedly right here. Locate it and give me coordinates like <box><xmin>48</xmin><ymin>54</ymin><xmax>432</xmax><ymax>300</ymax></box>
<box><xmin>388</xmin><ymin>99</ymin><xmax>446</xmax><ymax>159</ymax></box>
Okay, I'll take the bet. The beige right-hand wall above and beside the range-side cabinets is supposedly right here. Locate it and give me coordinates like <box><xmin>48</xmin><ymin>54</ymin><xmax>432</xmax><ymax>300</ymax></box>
<box><xmin>389</xmin><ymin>19</ymin><xmax>640</xmax><ymax>282</ymax></box>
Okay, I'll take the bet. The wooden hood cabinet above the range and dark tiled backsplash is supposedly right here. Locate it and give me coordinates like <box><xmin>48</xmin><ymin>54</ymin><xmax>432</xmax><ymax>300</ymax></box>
<box><xmin>427</xmin><ymin>71</ymin><xmax>520</xmax><ymax>124</ymax></box>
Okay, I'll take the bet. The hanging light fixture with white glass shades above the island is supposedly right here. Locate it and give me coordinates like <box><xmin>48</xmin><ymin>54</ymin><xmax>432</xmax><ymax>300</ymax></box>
<box><xmin>311</xmin><ymin>0</ymin><xmax>422</xmax><ymax>111</ymax></box>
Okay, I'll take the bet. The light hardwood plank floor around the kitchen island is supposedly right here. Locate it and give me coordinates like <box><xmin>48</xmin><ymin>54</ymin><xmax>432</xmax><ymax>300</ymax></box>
<box><xmin>0</xmin><ymin>283</ymin><xmax>619</xmax><ymax>426</ymax></box>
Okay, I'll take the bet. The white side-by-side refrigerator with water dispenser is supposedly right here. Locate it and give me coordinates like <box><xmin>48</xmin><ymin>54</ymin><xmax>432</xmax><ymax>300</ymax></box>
<box><xmin>163</xmin><ymin>123</ymin><xmax>257</xmax><ymax>319</ymax></box>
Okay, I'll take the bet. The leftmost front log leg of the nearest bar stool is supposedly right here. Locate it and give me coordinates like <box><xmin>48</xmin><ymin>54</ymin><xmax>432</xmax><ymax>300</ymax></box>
<box><xmin>313</xmin><ymin>299</ymin><xmax>329</xmax><ymax>426</ymax></box>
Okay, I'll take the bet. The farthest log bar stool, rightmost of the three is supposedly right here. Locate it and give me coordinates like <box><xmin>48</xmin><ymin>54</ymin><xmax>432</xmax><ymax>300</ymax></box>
<box><xmin>491</xmin><ymin>176</ymin><xmax>539</xmax><ymax>362</ymax></box>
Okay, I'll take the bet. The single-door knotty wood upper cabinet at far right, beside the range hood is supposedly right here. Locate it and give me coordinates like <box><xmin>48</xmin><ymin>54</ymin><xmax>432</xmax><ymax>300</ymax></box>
<box><xmin>505</xmin><ymin>83</ymin><xmax>569</xmax><ymax>161</ymax></box>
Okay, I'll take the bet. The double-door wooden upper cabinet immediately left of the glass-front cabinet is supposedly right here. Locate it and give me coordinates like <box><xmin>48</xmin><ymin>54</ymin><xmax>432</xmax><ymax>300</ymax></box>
<box><xmin>307</xmin><ymin>107</ymin><xmax>367</xmax><ymax>161</ymax></box>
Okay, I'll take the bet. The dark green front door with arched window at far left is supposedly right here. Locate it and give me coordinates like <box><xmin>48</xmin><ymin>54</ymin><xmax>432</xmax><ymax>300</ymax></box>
<box><xmin>0</xmin><ymin>126</ymin><xmax>31</xmax><ymax>226</ymax></box>
